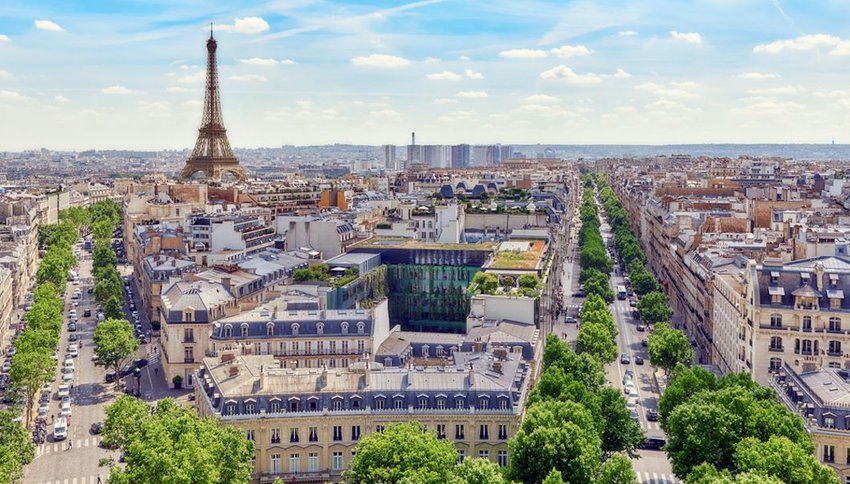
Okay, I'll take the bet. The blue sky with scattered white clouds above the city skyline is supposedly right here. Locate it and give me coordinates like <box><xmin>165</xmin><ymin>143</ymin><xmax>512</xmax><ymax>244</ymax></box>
<box><xmin>0</xmin><ymin>0</ymin><xmax>850</xmax><ymax>150</ymax></box>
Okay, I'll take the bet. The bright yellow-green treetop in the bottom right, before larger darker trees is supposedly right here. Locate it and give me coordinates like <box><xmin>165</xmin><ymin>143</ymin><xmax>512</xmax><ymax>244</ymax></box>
<box><xmin>734</xmin><ymin>436</ymin><xmax>839</xmax><ymax>484</ymax></box>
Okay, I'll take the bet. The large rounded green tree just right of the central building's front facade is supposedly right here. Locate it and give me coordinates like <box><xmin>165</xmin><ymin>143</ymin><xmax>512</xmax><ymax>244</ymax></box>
<box><xmin>508</xmin><ymin>402</ymin><xmax>602</xmax><ymax>482</ymax></box>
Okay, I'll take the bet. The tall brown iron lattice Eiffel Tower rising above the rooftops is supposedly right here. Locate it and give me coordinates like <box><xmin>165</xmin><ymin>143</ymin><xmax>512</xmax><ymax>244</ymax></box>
<box><xmin>180</xmin><ymin>24</ymin><xmax>248</xmax><ymax>181</ymax></box>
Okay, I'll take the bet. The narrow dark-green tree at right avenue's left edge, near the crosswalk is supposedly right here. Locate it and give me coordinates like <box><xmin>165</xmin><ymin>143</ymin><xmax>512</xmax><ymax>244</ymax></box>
<box><xmin>597</xmin><ymin>387</ymin><xmax>646</xmax><ymax>460</ymax></box>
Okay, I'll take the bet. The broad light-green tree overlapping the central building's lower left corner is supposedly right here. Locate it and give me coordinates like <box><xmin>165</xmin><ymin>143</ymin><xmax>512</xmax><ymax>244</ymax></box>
<box><xmin>104</xmin><ymin>396</ymin><xmax>254</xmax><ymax>484</ymax></box>
